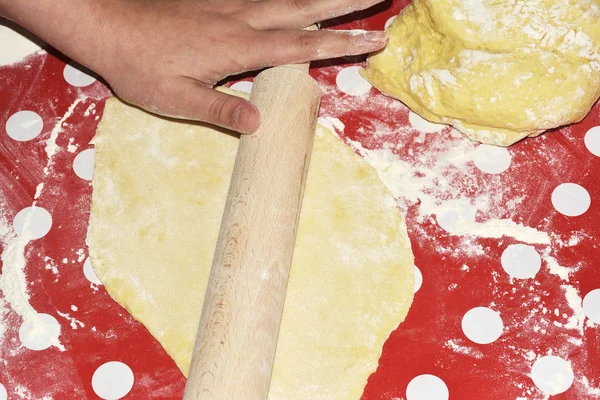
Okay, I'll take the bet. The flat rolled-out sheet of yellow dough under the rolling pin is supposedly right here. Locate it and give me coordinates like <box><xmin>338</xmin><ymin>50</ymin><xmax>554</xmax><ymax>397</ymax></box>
<box><xmin>87</xmin><ymin>92</ymin><xmax>414</xmax><ymax>400</ymax></box>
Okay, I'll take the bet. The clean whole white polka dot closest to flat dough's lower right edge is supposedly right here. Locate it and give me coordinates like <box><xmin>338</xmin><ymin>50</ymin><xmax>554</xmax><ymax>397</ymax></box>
<box><xmin>461</xmin><ymin>307</ymin><xmax>504</xmax><ymax>344</ymax></box>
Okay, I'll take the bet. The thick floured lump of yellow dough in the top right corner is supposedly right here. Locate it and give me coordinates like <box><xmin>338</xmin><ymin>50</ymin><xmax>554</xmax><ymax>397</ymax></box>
<box><xmin>364</xmin><ymin>0</ymin><xmax>600</xmax><ymax>146</ymax></box>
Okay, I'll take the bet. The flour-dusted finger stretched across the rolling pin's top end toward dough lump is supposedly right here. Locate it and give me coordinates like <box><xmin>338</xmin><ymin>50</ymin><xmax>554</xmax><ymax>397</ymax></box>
<box><xmin>244</xmin><ymin>30</ymin><xmax>387</xmax><ymax>69</ymax></box>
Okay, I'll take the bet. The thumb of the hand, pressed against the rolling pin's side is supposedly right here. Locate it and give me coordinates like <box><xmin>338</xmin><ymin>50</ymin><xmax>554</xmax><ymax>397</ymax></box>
<box><xmin>146</xmin><ymin>78</ymin><xmax>260</xmax><ymax>134</ymax></box>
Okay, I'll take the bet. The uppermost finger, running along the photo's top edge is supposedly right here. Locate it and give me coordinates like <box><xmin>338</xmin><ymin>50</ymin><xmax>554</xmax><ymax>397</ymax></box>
<box><xmin>247</xmin><ymin>0</ymin><xmax>382</xmax><ymax>30</ymax></box>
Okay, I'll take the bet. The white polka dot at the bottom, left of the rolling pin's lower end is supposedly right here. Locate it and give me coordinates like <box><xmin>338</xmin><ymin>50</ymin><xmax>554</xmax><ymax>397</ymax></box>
<box><xmin>92</xmin><ymin>361</ymin><xmax>134</xmax><ymax>400</ymax></box>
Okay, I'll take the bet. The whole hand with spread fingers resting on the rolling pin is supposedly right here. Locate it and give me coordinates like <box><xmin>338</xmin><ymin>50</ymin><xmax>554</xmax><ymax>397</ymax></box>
<box><xmin>91</xmin><ymin>0</ymin><xmax>387</xmax><ymax>133</ymax></box>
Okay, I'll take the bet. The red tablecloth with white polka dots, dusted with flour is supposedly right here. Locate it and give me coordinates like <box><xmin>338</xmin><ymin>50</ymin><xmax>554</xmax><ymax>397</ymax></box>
<box><xmin>0</xmin><ymin>1</ymin><xmax>600</xmax><ymax>400</ymax></box>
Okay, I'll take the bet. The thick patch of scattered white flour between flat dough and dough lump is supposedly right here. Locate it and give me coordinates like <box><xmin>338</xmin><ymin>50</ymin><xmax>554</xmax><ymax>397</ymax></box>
<box><xmin>349</xmin><ymin>134</ymin><xmax>551</xmax><ymax>244</ymax></box>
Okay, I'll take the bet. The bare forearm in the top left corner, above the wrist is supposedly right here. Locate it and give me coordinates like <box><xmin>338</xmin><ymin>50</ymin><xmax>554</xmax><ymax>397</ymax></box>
<box><xmin>0</xmin><ymin>0</ymin><xmax>123</xmax><ymax>72</ymax></box>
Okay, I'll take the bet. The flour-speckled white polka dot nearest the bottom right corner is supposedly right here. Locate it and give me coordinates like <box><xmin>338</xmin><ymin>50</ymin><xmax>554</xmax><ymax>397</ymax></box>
<box><xmin>531</xmin><ymin>356</ymin><xmax>573</xmax><ymax>395</ymax></box>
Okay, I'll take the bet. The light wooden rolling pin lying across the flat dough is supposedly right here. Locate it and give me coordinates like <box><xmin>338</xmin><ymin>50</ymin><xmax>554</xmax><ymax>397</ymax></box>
<box><xmin>184</xmin><ymin>64</ymin><xmax>321</xmax><ymax>400</ymax></box>
